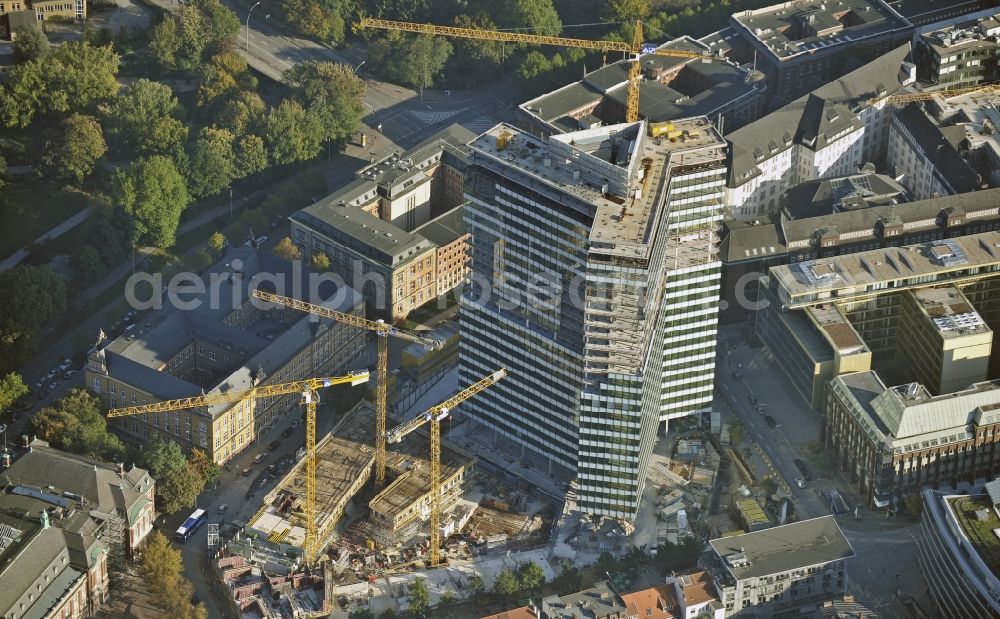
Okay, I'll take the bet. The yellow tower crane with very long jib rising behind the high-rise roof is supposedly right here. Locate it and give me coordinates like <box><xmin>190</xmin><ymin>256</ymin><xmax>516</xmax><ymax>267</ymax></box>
<box><xmin>358</xmin><ymin>17</ymin><xmax>721</xmax><ymax>123</ymax></box>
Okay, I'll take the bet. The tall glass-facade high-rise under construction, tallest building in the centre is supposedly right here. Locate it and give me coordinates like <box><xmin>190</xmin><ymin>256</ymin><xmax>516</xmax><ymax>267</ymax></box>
<box><xmin>459</xmin><ymin>117</ymin><xmax>726</xmax><ymax>519</ymax></box>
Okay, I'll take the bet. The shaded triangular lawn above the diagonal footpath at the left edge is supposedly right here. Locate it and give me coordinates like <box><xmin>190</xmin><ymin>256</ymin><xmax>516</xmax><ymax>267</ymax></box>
<box><xmin>0</xmin><ymin>181</ymin><xmax>88</xmax><ymax>257</ymax></box>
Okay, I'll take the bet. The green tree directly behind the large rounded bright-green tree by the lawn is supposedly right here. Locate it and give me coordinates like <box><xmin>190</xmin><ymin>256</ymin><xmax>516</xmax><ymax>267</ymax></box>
<box><xmin>105</xmin><ymin>78</ymin><xmax>188</xmax><ymax>155</ymax></box>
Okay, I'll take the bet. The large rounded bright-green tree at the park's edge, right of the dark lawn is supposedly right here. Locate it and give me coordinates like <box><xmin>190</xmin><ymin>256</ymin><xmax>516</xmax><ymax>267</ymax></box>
<box><xmin>112</xmin><ymin>156</ymin><xmax>191</xmax><ymax>249</ymax></box>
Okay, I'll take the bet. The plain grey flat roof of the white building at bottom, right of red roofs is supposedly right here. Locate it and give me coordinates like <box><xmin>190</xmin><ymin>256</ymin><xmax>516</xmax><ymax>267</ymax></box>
<box><xmin>709</xmin><ymin>516</ymin><xmax>854</xmax><ymax>580</ymax></box>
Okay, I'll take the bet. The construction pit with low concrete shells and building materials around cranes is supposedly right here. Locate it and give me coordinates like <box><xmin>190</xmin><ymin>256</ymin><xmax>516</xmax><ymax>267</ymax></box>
<box><xmin>247</xmin><ymin>401</ymin><xmax>546</xmax><ymax>580</ymax></box>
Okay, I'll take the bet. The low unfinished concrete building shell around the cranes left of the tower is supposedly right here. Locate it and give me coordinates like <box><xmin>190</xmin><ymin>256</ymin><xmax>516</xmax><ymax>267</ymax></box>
<box><xmin>248</xmin><ymin>400</ymin><xmax>474</xmax><ymax>560</ymax></box>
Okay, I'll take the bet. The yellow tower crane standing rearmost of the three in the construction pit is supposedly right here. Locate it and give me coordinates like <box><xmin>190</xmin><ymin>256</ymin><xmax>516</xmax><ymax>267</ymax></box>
<box><xmin>253</xmin><ymin>290</ymin><xmax>442</xmax><ymax>487</ymax></box>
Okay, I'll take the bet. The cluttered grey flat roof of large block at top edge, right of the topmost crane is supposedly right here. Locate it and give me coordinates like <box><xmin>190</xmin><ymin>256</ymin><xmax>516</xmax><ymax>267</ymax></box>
<box><xmin>732</xmin><ymin>0</ymin><xmax>912</xmax><ymax>61</ymax></box>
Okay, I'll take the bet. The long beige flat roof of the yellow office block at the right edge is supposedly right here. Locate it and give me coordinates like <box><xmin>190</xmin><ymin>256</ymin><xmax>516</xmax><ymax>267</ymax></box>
<box><xmin>770</xmin><ymin>231</ymin><xmax>1000</xmax><ymax>307</ymax></box>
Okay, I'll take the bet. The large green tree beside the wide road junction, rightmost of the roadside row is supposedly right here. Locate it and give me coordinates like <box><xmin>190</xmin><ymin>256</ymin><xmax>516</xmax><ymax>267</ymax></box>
<box><xmin>284</xmin><ymin>60</ymin><xmax>366</xmax><ymax>145</ymax></box>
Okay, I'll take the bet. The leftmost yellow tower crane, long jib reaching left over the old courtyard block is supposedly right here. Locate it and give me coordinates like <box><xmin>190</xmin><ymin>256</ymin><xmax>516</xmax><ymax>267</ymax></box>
<box><xmin>108</xmin><ymin>371</ymin><xmax>368</xmax><ymax>565</ymax></box>
